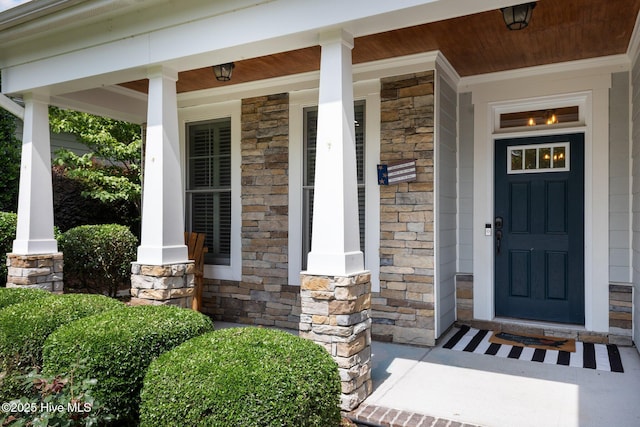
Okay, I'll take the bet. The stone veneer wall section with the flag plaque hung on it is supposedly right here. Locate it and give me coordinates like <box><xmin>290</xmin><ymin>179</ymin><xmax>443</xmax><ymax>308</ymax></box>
<box><xmin>371</xmin><ymin>71</ymin><xmax>435</xmax><ymax>345</ymax></box>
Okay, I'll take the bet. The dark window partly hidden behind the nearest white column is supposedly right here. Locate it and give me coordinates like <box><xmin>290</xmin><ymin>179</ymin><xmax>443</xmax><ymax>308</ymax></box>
<box><xmin>302</xmin><ymin>101</ymin><xmax>366</xmax><ymax>270</ymax></box>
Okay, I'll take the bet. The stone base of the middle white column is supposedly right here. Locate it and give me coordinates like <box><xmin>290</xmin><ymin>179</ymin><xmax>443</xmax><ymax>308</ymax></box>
<box><xmin>131</xmin><ymin>262</ymin><xmax>195</xmax><ymax>308</ymax></box>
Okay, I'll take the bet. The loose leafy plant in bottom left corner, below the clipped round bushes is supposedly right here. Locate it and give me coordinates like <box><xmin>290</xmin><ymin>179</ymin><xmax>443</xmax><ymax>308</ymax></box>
<box><xmin>0</xmin><ymin>370</ymin><xmax>113</xmax><ymax>427</ymax></box>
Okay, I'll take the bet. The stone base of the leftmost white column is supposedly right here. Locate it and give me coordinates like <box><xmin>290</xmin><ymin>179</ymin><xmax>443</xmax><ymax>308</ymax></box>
<box><xmin>7</xmin><ymin>252</ymin><xmax>64</xmax><ymax>294</ymax></box>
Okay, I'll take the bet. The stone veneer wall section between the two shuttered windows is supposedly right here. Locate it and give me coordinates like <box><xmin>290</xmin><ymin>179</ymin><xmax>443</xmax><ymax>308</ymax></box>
<box><xmin>202</xmin><ymin>94</ymin><xmax>300</xmax><ymax>329</ymax></box>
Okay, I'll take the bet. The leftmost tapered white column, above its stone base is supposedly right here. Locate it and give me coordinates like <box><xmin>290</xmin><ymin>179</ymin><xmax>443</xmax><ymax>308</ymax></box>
<box><xmin>13</xmin><ymin>94</ymin><xmax>58</xmax><ymax>255</ymax></box>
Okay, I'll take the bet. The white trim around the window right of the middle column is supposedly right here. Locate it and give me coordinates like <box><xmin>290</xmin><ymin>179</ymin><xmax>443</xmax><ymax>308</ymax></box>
<box><xmin>178</xmin><ymin>101</ymin><xmax>242</xmax><ymax>281</ymax></box>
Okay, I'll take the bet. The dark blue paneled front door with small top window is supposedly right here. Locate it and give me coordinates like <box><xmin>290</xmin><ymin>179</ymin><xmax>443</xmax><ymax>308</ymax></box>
<box><xmin>493</xmin><ymin>134</ymin><xmax>584</xmax><ymax>324</ymax></box>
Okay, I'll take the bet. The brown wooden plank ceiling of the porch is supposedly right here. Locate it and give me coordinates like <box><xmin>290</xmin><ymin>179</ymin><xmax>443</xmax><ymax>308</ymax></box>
<box><xmin>123</xmin><ymin>0</ymin><xmax>640</xmax><ymax>93</ymax></box>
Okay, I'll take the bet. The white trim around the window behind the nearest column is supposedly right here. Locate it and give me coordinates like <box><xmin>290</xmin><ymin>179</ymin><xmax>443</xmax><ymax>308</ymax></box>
<box><xmin>289</xmin><ymin>79</ymin><xmax>380</xmax><ymax>292</ymax></box>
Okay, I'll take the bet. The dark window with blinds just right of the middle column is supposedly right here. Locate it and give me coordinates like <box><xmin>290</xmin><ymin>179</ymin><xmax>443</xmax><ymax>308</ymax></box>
<box><xmin>186</xmin><ymin>119</ymin><xmax>231</xmax><ymax>265</ymax></box>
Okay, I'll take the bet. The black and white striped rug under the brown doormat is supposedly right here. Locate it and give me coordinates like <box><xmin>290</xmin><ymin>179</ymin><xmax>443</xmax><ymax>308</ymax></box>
<box><xmin>443</xmin><ymin>325</ymin><xmax>624</xmax><ymax>372</ymax></box>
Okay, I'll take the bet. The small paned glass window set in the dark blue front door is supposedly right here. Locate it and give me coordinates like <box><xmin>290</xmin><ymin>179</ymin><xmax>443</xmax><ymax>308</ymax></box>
<box><xmin>507</xmin><ymin>142</ymin><xmax>570</xmax><ymax>174</ymax></box>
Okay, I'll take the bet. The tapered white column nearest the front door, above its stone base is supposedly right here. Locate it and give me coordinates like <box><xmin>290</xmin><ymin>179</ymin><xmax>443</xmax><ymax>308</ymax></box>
<box><xmin>307</xmin><ymin>30</ymin><xmax>364</xmax><ymax>276</ymax></box>
